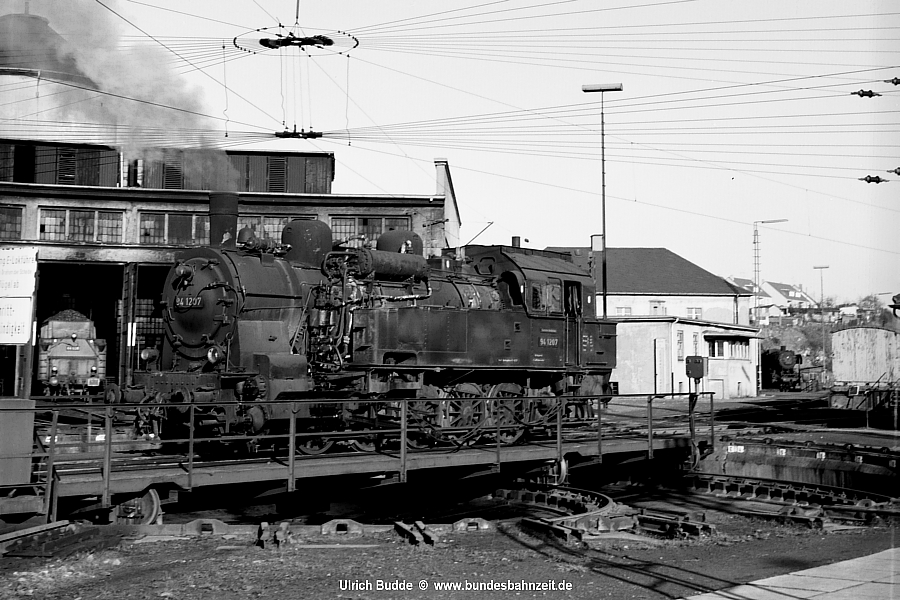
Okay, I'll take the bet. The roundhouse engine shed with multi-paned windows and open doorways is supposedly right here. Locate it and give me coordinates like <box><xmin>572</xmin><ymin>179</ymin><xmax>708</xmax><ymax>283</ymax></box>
<box><xmin>0</xmin><ymin>140</ymin><xmax>460</xmax><ymax>396</ymax></box>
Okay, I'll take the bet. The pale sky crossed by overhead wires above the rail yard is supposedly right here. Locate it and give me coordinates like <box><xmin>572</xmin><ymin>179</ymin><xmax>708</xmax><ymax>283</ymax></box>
<box><xmin>0</xmin><ymin>0</ymin><xmax>900</xmax><ymax>301</ymax></box>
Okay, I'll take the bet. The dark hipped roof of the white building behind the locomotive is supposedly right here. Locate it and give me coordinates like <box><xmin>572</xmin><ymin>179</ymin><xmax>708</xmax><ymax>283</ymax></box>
<box><xmin>547</xmin><ymin>247</ymin><xmax>750</xmax><ymax>296</ymax></box>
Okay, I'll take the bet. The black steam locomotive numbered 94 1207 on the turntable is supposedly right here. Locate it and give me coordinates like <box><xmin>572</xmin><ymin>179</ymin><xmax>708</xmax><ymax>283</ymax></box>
<box><xmin>123</xmin><ymin>194</ymin><xmax>615</xmax><ymax>453</ymax></box>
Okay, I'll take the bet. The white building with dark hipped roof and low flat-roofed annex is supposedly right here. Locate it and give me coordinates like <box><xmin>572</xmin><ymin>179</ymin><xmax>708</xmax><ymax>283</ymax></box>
<box><xmin>548</xmin><ymin>248</ymin><xmax>759</xmax><ymax>399</ymax></box>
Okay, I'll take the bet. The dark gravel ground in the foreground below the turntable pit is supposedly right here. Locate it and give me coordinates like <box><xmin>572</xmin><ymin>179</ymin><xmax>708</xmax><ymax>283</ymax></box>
<box><xmin>0</xmin><ymin>515</ymin><xmax>900</xmax><ymax>600</ymax></box>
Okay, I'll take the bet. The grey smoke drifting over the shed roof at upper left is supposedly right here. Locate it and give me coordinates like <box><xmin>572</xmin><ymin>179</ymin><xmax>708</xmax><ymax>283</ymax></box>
<box><xmin>0</xmin><ymin>0</ymin><xmax>239</xmax><ymax>185</ymax></box>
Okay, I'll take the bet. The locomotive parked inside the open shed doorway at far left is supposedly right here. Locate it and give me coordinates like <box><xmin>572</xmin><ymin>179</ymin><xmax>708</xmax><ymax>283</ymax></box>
<box><xmin>37</xmin><ymin>310</ymin><xmax>106</xmax><ymax>396</ymax></box>
